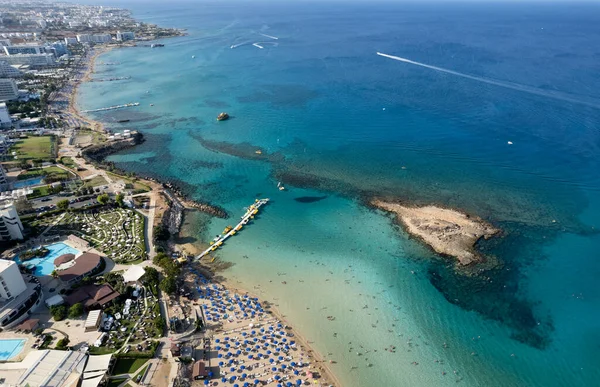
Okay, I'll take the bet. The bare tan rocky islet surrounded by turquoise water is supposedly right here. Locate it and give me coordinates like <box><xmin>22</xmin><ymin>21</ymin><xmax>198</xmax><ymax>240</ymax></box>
<box><xmin>371</xmin><ymin>199</ymin><xmax>500</xmax><ymax>266</ymax></box>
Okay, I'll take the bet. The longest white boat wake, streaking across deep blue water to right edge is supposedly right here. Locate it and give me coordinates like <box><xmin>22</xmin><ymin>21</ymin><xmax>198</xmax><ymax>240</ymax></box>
<box><xmin>377</xmin><ymin>52</ymin><xmax>600</xmax><ymax>109</ymax></box>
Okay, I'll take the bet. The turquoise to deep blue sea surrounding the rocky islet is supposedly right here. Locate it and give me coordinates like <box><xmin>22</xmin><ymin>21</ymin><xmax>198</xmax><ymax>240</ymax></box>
<box><xmin>78</xmin><ymin>2</ymin><xmax>600</xmax><ymax>386</ymax></box>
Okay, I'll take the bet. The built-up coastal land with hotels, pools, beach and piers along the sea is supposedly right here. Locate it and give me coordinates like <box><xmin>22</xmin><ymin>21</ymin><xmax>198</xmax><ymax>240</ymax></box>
<box><xmin>0</xmin><ymin>0</ymin><xmax>338</xmax><ymax>387</ymax></box>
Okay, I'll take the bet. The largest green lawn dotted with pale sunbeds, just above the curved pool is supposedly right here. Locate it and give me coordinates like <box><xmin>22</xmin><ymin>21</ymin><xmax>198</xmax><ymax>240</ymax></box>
<box><xmin>28</xmin><ymin>207</ymin><xmax>147</xmax><ymax>263</ymax></box>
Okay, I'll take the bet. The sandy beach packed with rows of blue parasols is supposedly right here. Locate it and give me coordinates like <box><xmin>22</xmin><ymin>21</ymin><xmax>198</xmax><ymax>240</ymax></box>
<box><xmin>185</xmin><ymin>267</ymin><xmax>341</xmax><ymax>386</ymax></box>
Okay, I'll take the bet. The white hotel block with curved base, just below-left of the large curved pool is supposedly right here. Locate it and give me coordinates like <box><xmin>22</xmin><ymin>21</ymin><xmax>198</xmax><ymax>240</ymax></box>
<box><xmin>0</xmin><ymin>259</ymin><xmax>42</xmax><ymax>329</ymax></box>
